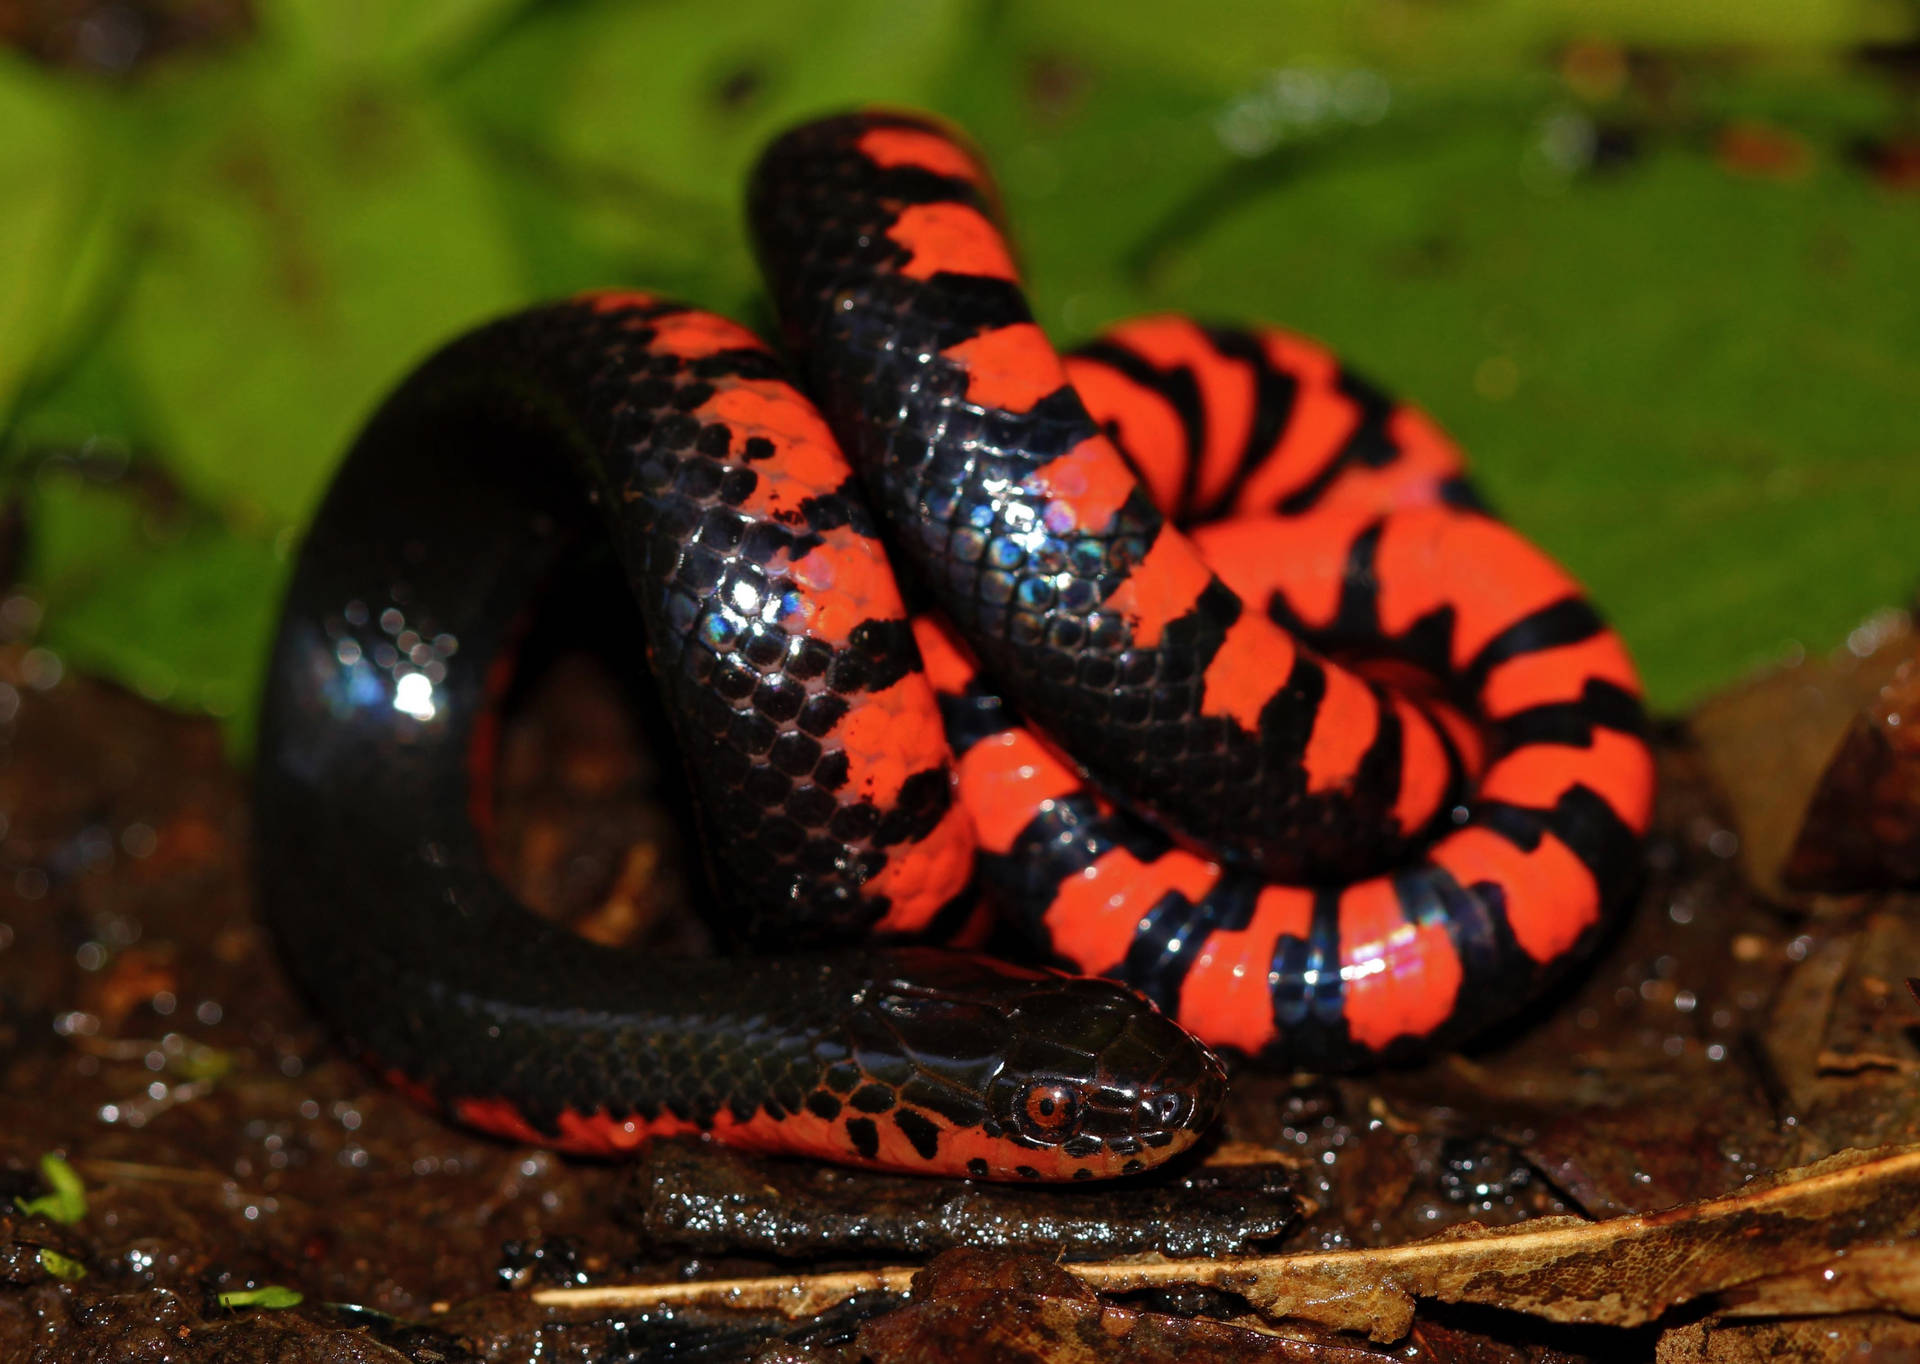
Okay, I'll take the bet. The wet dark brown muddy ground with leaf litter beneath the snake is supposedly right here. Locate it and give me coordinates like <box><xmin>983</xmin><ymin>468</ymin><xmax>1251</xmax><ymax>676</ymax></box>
<box><xmin>0</xmin><ymin>617</ymin><xmax>1920</xmax><ymax>1362</ymax></box>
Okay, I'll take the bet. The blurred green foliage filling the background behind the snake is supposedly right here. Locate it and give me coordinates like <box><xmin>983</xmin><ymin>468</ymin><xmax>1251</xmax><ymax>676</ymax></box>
<box><xmin>0</xmin><ymin>0</ymin><xmax>1920</xmax><ymax>749</ymax></box>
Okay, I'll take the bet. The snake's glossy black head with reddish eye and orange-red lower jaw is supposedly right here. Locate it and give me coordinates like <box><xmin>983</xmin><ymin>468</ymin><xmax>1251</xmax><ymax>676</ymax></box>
<box><xmin>829</xmin><ymin>953</ymin><xmax>1227</xmax><ymax>1181</ymax></box>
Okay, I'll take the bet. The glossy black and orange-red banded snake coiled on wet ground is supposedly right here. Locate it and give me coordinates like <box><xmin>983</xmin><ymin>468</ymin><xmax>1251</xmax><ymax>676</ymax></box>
<box><xmin>253</xmin><ymin>110</ymin><xmax>1653</xmax><ymax>1181</ymax></box>
